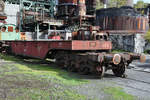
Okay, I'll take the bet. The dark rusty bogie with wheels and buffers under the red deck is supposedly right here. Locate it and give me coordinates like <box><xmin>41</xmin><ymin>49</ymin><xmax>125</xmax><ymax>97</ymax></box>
<box><xmin>56</xmin><ymin>51</ymin><xmax>144</xmax><ymax>78</ymax></box>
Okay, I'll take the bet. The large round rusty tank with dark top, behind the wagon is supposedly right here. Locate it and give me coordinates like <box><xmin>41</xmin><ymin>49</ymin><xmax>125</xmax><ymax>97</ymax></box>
<box><xmin>96</xmin><ymin>7</ymin><xmax>149</xmax><ymax>33</ymax></box>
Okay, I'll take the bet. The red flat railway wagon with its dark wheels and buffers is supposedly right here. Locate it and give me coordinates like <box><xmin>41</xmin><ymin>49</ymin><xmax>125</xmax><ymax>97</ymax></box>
<box><xmin>8</xmin><ymin>40</ymin><xmax>144</xmax><ymax>77</ymax></box>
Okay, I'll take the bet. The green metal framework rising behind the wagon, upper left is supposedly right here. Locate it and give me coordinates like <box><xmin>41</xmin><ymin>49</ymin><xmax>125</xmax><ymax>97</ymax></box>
<box><xmin>19</xmin><ymin>0</ymin><xmax>56</xmax><ymax>31</ymax></box>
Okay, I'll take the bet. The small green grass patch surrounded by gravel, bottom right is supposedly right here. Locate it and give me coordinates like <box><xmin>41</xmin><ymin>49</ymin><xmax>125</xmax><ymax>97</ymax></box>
<box><xmin>104</xmin><ymin>87</ymin><xmax>136</xmax><ymax>100</ymax></box>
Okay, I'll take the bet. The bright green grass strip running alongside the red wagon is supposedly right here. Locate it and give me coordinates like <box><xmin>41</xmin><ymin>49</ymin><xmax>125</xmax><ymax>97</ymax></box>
<box><xmin>1</xmin><ymin>55</ymin><xmax>88</xmax><ymax>85</ymax></box>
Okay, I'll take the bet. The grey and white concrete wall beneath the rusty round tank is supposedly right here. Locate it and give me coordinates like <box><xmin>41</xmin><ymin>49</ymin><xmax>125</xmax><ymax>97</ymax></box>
<box><xmin>111</xmin><ymin>34</ymin><xmax>145</xmax><ymax>53</ymax></box>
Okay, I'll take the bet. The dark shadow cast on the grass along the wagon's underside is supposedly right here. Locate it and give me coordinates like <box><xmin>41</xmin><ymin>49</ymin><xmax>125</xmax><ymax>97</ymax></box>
<box><xmin>0</xmin><ymin>56</ymin><xmax>116</xmax><ymax>80</ymax></box>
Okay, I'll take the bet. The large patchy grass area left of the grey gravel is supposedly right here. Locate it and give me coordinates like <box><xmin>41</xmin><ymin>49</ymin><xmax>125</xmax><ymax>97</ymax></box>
<box><xmin>0</xmin><ymin>55</ymin><xmax>89</xmax><ymax>100</ymax></box>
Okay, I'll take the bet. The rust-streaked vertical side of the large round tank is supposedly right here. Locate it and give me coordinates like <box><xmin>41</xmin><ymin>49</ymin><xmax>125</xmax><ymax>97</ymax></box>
<box><xmin>97</xmin><ymin>16</ymin><xmax>148</xmax><ymax>33</ymax></box>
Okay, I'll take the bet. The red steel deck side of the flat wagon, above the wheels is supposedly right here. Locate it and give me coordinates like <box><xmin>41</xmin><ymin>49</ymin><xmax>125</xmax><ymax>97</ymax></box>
<box><xmin>11</xmin><ymin>41</ymin><xmax>112</xmax><ymax>59</ymax></box>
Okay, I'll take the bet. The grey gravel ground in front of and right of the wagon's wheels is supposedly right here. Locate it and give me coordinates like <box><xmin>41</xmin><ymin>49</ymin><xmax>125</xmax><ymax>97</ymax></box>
<box><xmin>71</xmin><ymin>56</ymin><xmax>150</xmax><ymax>100</ymax></box>
